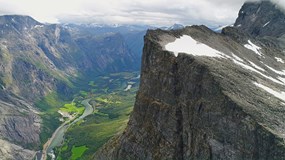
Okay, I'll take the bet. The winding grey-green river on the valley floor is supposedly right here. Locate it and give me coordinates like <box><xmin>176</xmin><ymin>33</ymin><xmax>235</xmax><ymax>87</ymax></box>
<box><xmin>38</xmin><ymin>99</ymin><xmax>93</xmax><ymax>160</ymax></box>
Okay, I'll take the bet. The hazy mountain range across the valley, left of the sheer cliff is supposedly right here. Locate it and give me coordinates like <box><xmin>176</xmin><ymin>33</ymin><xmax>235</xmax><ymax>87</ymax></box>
<box><xmin>0</xmin><ymin>15</ymin><xmax>143</xmax><ymax>159</ymax></box>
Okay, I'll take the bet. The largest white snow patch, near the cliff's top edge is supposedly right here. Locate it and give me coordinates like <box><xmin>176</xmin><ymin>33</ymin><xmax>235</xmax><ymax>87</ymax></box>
<box><xmin>165</xmin><ymin>35</ymin><xmax>225</xmax><ymax>58</ymax></box>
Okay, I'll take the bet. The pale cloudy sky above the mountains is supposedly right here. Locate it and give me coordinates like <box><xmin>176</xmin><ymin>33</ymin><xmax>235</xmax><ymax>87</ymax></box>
<box><xmin>0</xmin><ymin>0</ymin><xmax>276</xmax><ymax>26</ymax></box>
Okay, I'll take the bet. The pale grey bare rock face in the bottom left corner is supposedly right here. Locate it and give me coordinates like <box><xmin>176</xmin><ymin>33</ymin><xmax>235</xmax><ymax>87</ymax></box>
<box><xmin>0</xmin><ymin>94</ymin><xmax>41</xmax><ymax>160</ymax></box>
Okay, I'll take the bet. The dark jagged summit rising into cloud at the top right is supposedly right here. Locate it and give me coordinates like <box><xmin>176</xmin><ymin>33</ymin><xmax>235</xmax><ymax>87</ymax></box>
<box><xmin>234</xmin><ymin>1</ymin><xmax>285</xmax><ymax>37</ymax></box>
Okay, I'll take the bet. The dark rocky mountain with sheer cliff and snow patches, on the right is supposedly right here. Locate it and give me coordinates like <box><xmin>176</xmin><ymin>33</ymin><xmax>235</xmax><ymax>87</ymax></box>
<box><xmin>94</xmin><ymin>1</ymin><xmax>285</xmax><ymax>160</ymax></box>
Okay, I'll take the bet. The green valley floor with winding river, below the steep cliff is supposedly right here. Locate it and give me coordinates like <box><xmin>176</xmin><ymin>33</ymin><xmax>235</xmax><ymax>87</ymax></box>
<box><xmin>37</xmin><ymin>72</ymin><xmax>139</xmax><ymax>160</ymax></box>
